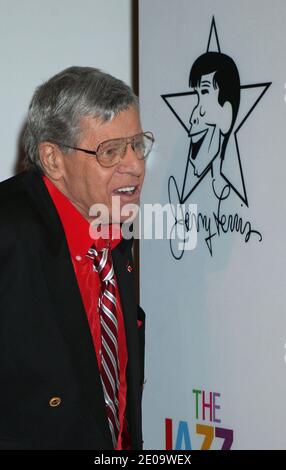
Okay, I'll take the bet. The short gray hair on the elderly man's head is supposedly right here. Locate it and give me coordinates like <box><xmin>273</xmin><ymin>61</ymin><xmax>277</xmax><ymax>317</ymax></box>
<box><xmin>23</xmin><ymin>66</ymin><xmax>139</xmax><ymax>172</ymax></box>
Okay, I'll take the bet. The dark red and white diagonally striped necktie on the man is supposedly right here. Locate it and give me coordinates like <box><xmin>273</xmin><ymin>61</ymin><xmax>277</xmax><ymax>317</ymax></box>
<box><xmin>87</xmin><ymin>248</ymin><xmax>120</xmax><ymax>447</ymax></box>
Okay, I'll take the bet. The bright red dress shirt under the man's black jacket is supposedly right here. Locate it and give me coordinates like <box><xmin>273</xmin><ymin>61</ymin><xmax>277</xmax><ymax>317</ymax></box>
<box><xmin>43</xmin><ymin>176</ymin><xmax>130</xmax><ymax>450</ymax></box>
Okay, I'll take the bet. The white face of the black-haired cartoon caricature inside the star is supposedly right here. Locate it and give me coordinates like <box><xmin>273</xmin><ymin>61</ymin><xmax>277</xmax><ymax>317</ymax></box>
<box><xmin>189</xmin><ymin>72</ymin><xmax>232</xmax><ymax>177</ymax></box>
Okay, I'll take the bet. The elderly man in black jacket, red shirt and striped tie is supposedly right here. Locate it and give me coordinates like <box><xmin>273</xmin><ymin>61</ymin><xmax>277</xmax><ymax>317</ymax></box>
<box><xmin>0</xmin><ymin>67</ymin><xmax>153</xmax><ymax>449</ymax></box>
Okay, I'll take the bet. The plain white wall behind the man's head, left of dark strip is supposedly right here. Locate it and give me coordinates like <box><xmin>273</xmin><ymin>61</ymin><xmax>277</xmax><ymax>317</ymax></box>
<box><xmin>0</xmin><ymin>0</ymin><xmax>131</xmax><ymax>180</ymax></box>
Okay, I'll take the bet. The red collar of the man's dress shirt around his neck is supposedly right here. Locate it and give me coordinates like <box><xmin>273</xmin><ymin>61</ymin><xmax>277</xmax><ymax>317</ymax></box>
<box><xmin>43</xmin><ymin>176</ymin><xmax>122</xmax><ymax>261</ymax></box>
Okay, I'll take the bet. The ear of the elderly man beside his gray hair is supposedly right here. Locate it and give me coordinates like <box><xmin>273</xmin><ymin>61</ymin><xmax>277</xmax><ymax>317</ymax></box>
<box><xmin>39</xmin><ymin>142</ymin><xmax>63</xmax><ymax>180</ymax></box>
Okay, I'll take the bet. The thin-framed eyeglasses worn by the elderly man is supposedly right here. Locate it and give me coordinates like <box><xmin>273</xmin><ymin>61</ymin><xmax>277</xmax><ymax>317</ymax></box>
<box><xmin>55</xmin><ymin>132</ymin><xmax>155</xmax><ymax>168</ymax></box>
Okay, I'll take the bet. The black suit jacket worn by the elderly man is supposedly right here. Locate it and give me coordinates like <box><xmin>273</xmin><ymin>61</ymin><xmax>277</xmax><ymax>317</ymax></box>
<box><xmin>0</xmin><ymin>172</ymin><xmax>144</xmax><ymax>449</ymax></box>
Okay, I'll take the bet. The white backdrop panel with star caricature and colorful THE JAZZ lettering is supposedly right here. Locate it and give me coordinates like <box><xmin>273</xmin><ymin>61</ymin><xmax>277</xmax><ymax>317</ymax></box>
<box><xmin>140</xmin><ymin>0</ymin><xmax>286</xmax><ymax>449</ymax></box>
